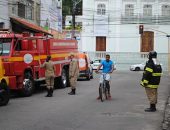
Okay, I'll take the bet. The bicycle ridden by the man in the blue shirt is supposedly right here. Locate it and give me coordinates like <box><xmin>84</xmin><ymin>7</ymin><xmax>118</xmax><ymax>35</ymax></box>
<box><xmin>99</xmin><ymin>73</ymin><xmax>109</xmax><ymax>102</ymax></box>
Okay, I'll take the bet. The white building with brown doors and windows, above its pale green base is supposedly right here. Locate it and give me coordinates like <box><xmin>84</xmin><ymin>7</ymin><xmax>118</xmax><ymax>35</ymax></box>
<box><xmin>82</xmin><ymin>0</ymin><xmax>170</xmax><ymax>53</ymax></box>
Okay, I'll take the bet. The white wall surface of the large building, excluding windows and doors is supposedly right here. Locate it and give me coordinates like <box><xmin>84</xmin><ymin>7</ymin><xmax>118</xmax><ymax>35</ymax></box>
<box><xmin>82</xmin><ymin>0</ymin><xmax>170</xmax><ymax>53</ymax></box>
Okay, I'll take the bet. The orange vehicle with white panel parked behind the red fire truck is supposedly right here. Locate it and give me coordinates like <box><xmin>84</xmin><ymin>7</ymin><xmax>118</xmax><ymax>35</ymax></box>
<box><xmin>78</xmin><ymin>53</ymin><xmax>93</xmax><ymax>80</ymax></box>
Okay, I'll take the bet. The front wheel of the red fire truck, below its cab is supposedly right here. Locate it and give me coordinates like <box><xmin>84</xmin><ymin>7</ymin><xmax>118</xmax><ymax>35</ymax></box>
<box><xmin>22</xmin><ymin>71</ymin><xmax>34</xmax><ymax>97</ymax></box>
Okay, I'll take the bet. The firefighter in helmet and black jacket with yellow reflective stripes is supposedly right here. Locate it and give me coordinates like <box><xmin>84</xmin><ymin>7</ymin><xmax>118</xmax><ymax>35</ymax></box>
<box><xmin>141</xmin><ymin>51</ymin><xmax>162</xmax><ymax>112</ymax></box>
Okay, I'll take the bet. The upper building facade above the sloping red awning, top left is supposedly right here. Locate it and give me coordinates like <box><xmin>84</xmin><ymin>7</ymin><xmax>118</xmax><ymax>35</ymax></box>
<box><xmin>0</xmin><ymin>0</ymin><xmax>41</xmax><ymax>28</ymax></box>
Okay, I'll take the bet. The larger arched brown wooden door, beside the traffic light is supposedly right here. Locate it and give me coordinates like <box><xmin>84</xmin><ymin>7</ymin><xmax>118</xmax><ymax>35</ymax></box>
<box><xmin>141</xmin><ymin>31</ymin><xmax>154</xmax><ymax>52</ymax></box>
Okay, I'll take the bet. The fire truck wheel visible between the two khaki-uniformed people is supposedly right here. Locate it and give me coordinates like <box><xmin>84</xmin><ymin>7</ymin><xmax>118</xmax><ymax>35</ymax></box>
<box><xmin>59</xmin><ymin>69</ymin><xmax>68</xmax><ymax>88</ymax></box>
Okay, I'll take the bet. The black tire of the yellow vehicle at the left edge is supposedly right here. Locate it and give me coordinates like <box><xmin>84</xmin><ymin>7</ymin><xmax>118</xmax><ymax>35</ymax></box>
<box><xmin>0</xmin><ymin>82</ymin><xmax>10</xmax><ymax>106</ymax></box>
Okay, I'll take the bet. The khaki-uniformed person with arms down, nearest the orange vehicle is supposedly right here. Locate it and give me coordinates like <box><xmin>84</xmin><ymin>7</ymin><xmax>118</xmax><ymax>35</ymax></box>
<box><xmin>68</xmin><ymin>53</ymin><xmax>79</xmax><ymax>95</ymax></box>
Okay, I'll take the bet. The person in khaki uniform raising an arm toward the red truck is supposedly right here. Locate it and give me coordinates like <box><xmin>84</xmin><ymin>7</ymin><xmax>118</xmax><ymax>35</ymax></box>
<box><xmin>40</xmin><ymin>55</ymin><xmax>55</xmax><ymax>97</ymax></box>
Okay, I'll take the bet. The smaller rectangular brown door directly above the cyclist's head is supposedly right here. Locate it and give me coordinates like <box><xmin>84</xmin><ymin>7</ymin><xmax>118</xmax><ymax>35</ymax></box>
<box><xmin>96</xmin><ymin>37</ymin><xmax>106</xmax><ymax>51</ymax></box>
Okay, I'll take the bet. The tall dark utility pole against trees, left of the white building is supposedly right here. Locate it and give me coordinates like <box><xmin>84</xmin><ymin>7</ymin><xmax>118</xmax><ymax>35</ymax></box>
<box><xmin>72</xmin><ymin>0</ymin><xmax>82</xmax><ymax>38</ymax></box>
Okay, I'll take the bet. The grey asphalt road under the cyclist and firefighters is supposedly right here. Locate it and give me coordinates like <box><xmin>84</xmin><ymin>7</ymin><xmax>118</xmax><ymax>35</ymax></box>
<box><xmin>0</xmin><ymin>71</ymin><xmax>169</xmax><ymax>130</ymax></box>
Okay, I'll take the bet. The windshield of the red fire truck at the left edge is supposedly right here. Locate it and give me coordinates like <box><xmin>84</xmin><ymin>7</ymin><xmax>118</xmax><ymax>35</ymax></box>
<box><xmin>0</xmin><ymin>38</ymin><xmax>12</xmax><ymax>56</ymax></box>
